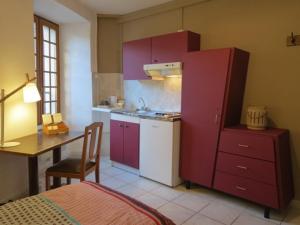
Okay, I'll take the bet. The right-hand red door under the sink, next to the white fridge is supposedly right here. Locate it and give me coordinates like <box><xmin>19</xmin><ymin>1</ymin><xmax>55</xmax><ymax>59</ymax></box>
<box><xmin>123</xmin><ymin>122</ymin><xmax>140</xmax><ymax>169</ymax></box>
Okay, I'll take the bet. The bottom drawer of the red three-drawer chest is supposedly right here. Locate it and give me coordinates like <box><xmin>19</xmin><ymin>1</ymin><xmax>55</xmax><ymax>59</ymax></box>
<box><xmin>214</xmin><ymin>172</ymin><xmax>279</xmax><ymax>209</ymax></box>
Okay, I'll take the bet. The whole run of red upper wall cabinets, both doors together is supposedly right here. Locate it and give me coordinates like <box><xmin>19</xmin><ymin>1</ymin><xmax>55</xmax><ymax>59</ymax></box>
<box><xmin>123</xmin><ymin>31</ymin><xmax>200</xmax><ymax>80</ymax></box>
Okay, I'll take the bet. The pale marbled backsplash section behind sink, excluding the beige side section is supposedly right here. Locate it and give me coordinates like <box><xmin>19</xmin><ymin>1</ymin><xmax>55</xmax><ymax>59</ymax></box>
<box><xmin>124</xmin><ymin>78</ymin><xmax>181</xmax><ymax>112</ymax></box>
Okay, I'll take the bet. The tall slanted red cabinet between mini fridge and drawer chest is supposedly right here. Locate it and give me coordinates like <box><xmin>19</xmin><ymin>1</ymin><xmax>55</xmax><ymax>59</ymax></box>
<box><xmin>180</xmin><ymin>48</ymin><xmax>249</xmax><ymax>187</ymax></box>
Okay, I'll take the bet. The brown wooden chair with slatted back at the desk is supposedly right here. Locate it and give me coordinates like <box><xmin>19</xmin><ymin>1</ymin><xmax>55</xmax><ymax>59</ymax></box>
<box><xmin>46</xmin><ymin>122</ymin><xmax>103</xmax><ymax>190</ymax></box>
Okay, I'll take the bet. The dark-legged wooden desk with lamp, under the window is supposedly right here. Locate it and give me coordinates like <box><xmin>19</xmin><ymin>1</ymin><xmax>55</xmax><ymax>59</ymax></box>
<box><xmin>0</xmin><ymin>131</ymin><xmax>84</xmax><ymax>195</ymax></box>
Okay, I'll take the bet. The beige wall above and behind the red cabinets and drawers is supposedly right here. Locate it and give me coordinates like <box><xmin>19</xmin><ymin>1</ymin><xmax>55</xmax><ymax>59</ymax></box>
<box><xmin>117</xmin><ymin>0</ymin><xmax>300</xmax><ymax>199</ymax></box>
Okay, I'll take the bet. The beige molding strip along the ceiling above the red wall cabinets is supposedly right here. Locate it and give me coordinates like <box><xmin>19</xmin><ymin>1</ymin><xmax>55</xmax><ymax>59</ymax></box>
<box><xmin>119</xmin><ymin>0</ymin><xmax>211</xmax><ymax>23</ymax></box>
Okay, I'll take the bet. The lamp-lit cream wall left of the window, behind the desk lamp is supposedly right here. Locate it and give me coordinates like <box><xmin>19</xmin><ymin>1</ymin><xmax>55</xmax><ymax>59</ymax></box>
<box><xmin>0</xmin><ymin>0</ymin><xmax>36</xmax><ymax>202</ymax></box>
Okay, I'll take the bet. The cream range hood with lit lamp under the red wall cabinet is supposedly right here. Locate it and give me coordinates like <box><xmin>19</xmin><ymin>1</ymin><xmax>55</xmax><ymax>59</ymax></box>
<box><xmin>144</xmin><ymin>62</ymin><xmax>182</xmax><ymax>80</ymax></box>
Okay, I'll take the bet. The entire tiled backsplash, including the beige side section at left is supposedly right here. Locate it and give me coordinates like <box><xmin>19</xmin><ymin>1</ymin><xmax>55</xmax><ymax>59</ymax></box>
<box><xmin>93</xmin><ymin>73</ymin><xmax>182</xmax><ymax>112</ymax></box>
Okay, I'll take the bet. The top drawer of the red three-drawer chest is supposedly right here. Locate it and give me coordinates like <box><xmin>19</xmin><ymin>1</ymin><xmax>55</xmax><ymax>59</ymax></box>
<box><xmin>219</xmin><ymin>131</ymin><xmax>275</xmax><ymax>162</ymax></box>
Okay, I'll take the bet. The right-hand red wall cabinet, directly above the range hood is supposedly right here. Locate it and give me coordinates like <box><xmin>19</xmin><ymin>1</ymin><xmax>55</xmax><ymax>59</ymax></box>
<box><xmin>152</xmin><ymin>31</ymin><xmax>200</xmax><ymax>63</ymax></box>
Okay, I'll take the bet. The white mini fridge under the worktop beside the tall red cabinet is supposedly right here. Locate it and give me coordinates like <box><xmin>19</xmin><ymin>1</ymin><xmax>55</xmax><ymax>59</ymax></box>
<box><xmin>140</xmin><ymin>119</ymin><xmax>181</xmax><ymax>187</ymax></box>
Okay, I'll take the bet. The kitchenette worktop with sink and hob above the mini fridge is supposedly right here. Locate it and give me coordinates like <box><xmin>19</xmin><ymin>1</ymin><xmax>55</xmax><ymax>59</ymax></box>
<box><xmin>111</xmin><ymin>110</ymin><xmax>181</xmax><ymax>122</ymax></box>
